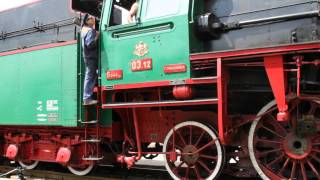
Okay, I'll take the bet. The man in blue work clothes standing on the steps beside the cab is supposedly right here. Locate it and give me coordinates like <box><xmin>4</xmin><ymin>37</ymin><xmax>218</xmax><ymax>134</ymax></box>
<box><xmin>81</xmin><ymin>14</ymin><xmax>100</xmax><ymax>106</ymax></box>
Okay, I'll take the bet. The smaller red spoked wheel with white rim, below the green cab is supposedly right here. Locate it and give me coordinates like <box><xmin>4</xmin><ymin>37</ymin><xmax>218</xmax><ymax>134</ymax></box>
<box><xmin>163</xmin><ymin>121</ymin><xmax>225</xmax><ymax>180</ymax></box>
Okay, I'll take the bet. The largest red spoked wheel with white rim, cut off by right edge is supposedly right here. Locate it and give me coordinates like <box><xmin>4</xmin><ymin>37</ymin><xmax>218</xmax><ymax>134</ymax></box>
<box><xmin>249</xmin><ymin>98</ymin><xmax>320</xmax><ymax>180</ymax></box>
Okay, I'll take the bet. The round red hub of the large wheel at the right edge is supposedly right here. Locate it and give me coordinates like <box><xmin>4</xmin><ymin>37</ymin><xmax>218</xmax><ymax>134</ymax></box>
<box><xmin>283</xmin><ymin>134</ymin><xmax>312</xmax><ymax>160</ymax></box>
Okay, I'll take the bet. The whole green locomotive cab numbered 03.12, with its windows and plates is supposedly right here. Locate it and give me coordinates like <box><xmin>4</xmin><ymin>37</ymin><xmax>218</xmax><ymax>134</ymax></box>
<box><xmin>100</xmin><ymin>0</ymin><xmax>190</xmax><ymax>86</ymax></box>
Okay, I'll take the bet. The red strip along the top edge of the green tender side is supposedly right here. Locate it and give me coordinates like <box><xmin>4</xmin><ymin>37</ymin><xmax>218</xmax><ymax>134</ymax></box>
<box><xmin>0</xmin><ymin>40</ymin><xmax>77</xmax><ymax>56</ymax></box>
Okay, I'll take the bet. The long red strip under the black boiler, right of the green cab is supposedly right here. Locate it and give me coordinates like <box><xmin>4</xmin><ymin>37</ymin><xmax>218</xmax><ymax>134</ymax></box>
<box><xmin>190</xmin><ymin>43</ymin><xmax>320</xmax><ymax>61</ymax></box>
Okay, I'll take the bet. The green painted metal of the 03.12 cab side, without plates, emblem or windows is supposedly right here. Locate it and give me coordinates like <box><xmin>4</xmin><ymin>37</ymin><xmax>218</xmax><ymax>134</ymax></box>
<box><xmin>101</xmin><ymin>0</ymin><xmax>190</xmax><ymax>86</ymax></box>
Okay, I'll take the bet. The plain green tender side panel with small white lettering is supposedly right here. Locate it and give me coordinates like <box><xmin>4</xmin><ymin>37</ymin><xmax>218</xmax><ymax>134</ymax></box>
<box><xmin>0</xmin><ymin>44</ymin><xmax>79</xmax><ymax>127</ymax></box>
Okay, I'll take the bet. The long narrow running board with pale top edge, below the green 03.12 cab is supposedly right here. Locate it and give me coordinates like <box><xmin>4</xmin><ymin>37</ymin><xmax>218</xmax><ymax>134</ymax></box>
<box><xmin>102</xmin><ymin>98</ymin><xmax>218</xmax><ymax>109</ymax></box>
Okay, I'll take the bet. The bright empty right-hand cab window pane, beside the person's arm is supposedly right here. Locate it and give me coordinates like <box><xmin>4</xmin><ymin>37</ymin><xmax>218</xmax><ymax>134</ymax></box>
<box><xmin>145</xmin><ymin>0</ymin><xmax>181</xmax><ymax>20</ymax></box>
